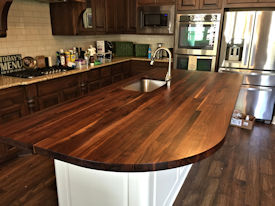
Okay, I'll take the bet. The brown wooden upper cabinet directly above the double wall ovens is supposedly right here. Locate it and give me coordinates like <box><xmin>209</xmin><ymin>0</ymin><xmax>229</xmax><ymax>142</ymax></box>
<box><xmin>178</xmin><ymin>0</ymin><xmax>222</xmax><ymax>10</ymax></box>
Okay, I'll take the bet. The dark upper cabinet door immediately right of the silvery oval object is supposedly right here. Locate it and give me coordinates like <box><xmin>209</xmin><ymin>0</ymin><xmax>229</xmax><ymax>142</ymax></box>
<box><xmin>93</xmin><ymin>0</ymin><xmax>106</xmax><ymax>33</ymax></box>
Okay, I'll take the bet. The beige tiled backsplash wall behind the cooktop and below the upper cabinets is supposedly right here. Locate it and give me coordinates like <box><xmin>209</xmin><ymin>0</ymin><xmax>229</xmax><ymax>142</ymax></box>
<box><xmin>0</xmin><ymin>0</ymin><xmax>173</xmax><ymax>62</ymax></box>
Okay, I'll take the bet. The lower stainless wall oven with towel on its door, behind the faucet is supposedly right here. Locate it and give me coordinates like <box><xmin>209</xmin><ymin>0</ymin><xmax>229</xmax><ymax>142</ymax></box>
<box><xmin>174</xmin><ymin>54</ymin><xmax>216</xmax><ymax>71</ymax></box>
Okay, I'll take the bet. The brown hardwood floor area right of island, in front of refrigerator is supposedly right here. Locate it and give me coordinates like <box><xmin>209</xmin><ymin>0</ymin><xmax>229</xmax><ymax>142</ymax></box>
<box><xmin>174</xmin><ymin>124</ymin><xmax>275</xmax><ymax>206</ymax></box>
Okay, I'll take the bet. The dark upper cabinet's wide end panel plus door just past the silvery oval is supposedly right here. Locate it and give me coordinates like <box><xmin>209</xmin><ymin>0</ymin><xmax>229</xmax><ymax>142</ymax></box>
<box><xmin>50</xmin><ymin>0</ymin><xmax>106</xmax><ymax>35</ymax></box>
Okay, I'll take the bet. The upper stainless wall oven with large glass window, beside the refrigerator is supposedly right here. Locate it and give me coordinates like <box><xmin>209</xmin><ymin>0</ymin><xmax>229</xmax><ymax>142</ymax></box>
<box><xmin>175</xmin><ymin>14</ymin><xmax>221</xmax><ymax>56</ymax></box>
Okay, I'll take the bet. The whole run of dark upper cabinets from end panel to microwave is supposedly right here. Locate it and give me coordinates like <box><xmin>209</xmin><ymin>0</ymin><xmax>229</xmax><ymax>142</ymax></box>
<box><xmin>50</xmin><ymin>0</ymin><xmax>137</xmax><ymax>35</ymax></box>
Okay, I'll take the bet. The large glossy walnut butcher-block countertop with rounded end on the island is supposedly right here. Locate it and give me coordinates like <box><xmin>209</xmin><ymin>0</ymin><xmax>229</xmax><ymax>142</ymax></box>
<box><xmin>0</xmin><ymin>69</ymin><xmax>242</xmax><ymax>172</ymax></box>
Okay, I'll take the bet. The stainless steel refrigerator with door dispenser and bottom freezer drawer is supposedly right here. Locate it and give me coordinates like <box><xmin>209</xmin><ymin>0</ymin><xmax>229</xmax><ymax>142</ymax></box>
<box><xmin>219</xmin><ymin>11</ymin><xmax>275</xmax><ymax>122</ymax></box>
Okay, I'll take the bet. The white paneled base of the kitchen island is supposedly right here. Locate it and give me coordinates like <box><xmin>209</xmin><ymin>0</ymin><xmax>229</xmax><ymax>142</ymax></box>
<box><xmin>54</xmin><ymin>160</ymin><xmax>192</xmax><ymax>206</ymax></box>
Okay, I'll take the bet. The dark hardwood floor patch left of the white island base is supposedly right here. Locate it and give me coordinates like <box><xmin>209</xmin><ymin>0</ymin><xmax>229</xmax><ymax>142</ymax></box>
<box><xmin>0</xmin><ymin>155</ymin><xmax>57</xmax><ymax>206</ymax></box>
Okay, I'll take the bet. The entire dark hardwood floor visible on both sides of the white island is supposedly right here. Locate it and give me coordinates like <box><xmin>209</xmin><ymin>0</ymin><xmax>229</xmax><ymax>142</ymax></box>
<box><xmin>0</xmin><ymin>123</ymin><xmax>275</xmax><ymax>206</ymax></box>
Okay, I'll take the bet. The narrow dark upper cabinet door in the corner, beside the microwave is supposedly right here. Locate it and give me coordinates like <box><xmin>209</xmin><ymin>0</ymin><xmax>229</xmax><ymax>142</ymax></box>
<box><xmin>126</xmin><ymin>0</ymin><xmax>137</xmax><ymax>33</ymax></box>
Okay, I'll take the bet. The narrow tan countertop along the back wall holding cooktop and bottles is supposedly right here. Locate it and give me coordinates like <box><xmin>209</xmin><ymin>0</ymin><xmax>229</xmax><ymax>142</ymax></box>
<box><xmin>0</xmin><ymin>57</ymin><xmax>172</xmax><ymax>89</ymax></box>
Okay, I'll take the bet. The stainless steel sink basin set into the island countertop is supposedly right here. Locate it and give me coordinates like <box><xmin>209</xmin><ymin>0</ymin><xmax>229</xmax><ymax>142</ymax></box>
<box><xmin>123</xmin><ymin>78</ymin><xmax>166</xmax><ymax>92</ymax></box>
